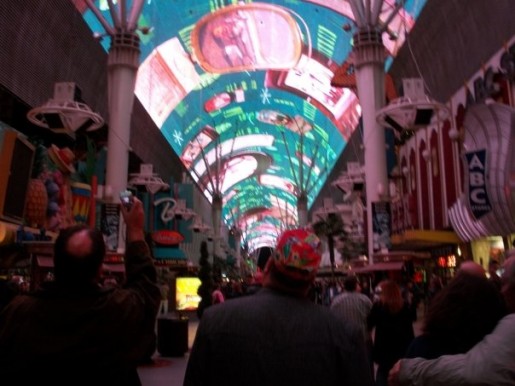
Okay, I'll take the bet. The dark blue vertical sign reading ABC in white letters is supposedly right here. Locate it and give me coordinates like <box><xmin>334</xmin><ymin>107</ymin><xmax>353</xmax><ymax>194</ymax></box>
<box><xmin>465</xmin><ymin>149</ymin><xmax>492</xmax><ymax>219</ymax></box>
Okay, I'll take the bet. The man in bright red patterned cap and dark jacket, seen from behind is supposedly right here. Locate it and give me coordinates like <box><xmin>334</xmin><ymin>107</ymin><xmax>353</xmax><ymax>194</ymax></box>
<box><xmin>184</xmin><ymin>229</ymin><xmax>373</xmax><ymax>386</ymax></box>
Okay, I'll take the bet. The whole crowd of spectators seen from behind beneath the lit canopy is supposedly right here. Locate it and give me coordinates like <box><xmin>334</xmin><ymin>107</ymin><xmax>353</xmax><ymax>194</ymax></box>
<box><xmin>0</xmin><ymin>202</ymin><xmax>515</xmax><ymax>386</ymax></box>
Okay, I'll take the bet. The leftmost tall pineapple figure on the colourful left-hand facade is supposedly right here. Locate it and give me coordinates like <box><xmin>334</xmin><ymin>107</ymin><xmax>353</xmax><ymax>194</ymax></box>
<box><xmin>25</xmin><ymin>143</ymin><xmax>48</xmax><ymax>228</ymax></box>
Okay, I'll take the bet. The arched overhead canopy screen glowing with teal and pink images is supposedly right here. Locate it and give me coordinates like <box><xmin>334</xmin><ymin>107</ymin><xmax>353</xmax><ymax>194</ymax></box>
<box><xmin>83</xmin><ymin>0</ymin><xmax>425</xmax><ymax>249</ymax></box>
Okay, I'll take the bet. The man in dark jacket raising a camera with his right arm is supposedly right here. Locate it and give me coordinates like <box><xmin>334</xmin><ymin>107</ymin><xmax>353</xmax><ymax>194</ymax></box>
<box><xmin>0</xmin><ymin>198</ymin><xmax>161</xmax><ymax>386</ymax></box>
